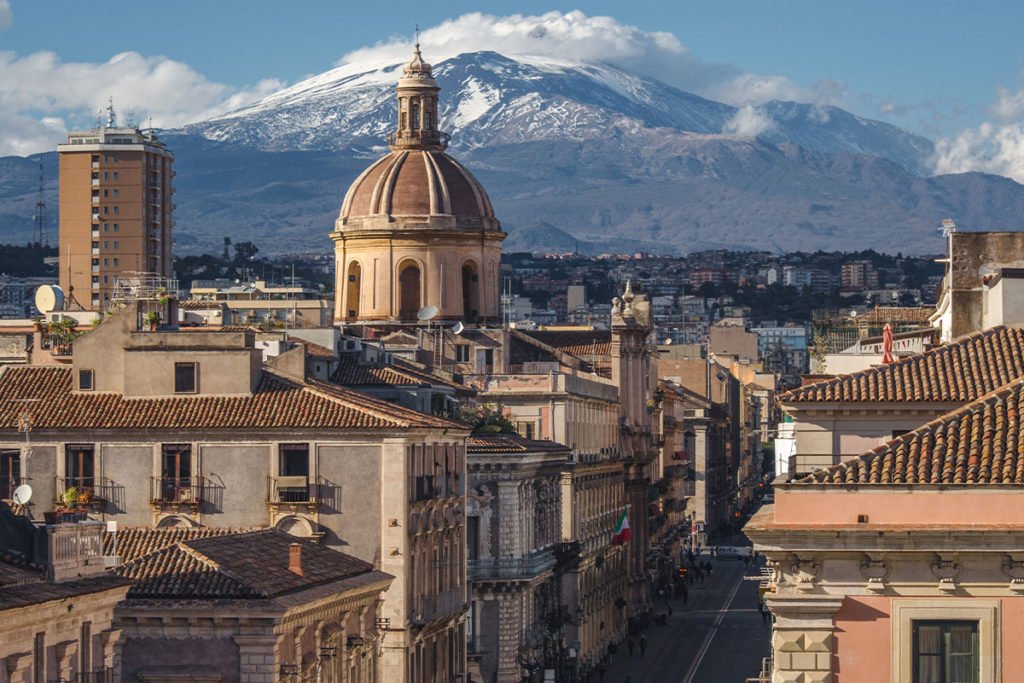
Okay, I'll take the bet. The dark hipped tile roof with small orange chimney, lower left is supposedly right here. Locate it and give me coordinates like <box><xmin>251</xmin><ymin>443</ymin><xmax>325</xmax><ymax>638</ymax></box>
<box><xmin>118</xmin><ymin>529</ymin><xmax>374</xmax><ymax>599</ymax></box>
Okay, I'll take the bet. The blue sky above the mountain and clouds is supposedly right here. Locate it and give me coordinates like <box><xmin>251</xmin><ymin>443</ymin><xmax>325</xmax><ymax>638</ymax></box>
<box><xmin>0</xmin><ymin>0</ymin><xmax>1024</xmax><ymax>179</ymax></box>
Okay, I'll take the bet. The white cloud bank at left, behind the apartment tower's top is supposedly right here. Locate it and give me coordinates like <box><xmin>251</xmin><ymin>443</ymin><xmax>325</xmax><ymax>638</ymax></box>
<box><xmin>0</xmin><ymin>50</ymin><xmax>283</xmax><ymax>155</ymax></box>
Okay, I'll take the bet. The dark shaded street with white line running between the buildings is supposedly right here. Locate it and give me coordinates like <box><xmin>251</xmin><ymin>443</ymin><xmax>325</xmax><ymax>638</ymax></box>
<box><xmin>596</xmin><ymin>554</ymin><xmax>771</xmax><ymax>683</ymax></box>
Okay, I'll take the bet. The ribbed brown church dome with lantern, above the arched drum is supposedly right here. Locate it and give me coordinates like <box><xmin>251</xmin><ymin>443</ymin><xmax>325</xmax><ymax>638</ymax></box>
<box><xmin>337</xmin><ymin>44</ymin><xmax>501</xmax><ymax>232</ymax></box>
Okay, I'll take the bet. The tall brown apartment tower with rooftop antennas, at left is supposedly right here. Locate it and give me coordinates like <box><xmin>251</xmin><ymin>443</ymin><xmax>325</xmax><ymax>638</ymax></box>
<box><xmin>57</xmin><ymin>111</ymin><xmax>174</xmax><ymax>310</ymax></box>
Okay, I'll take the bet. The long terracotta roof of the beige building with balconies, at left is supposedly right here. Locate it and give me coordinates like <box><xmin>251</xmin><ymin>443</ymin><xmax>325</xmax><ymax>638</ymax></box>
<box><xmin>0</xmin><ymin>367</ymin><xmax>460</xmax><ymax>430</ymax></box>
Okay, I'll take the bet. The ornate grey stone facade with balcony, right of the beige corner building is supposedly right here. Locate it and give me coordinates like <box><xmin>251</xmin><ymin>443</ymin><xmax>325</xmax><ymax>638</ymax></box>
<box><xmin>468</xmin><ymin>436</ymin><xmax>574</xmax><ymax>683</ymax></box>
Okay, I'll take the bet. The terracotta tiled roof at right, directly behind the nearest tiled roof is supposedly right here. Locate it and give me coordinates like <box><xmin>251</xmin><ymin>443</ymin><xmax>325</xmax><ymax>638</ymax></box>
<box><xmin>779</xmin><ymin>327</ymin><xmax>1024</xmax><ymax>403</ymax></box>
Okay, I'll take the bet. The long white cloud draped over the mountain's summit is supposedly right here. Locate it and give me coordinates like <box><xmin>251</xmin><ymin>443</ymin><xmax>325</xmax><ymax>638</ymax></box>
<box><xmin>337</xmin><ymin>10</ymin><xmax>798</xmax><ymax>104</ymax></box>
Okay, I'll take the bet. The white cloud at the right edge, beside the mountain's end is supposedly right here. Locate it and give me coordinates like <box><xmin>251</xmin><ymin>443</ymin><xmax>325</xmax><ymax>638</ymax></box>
<box><xmin>934</xmin><ymin>122</ymin><xmax>1024</xmax><ymax>182</ymax></box>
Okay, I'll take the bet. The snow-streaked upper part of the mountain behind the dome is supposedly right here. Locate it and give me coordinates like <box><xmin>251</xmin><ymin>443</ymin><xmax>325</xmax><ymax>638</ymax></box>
<box><xmin>181</xmin><ymin>52</ymin><xmax>933</xmax><ymax>173</ymax></box>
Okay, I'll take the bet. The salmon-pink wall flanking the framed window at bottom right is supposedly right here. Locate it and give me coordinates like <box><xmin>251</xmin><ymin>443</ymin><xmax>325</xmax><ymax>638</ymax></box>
<box><xmin>833</xmin><ymin>595</ymin><xmax>1024</xmax><ymax>683</ymax></box>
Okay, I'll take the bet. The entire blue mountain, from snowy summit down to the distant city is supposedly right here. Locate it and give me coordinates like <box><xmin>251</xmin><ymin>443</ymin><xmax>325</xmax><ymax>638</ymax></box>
<box><xmin>0</xmin><ymin>52</ymin><xmax>1024</xmax><ymax>253</ymax></box>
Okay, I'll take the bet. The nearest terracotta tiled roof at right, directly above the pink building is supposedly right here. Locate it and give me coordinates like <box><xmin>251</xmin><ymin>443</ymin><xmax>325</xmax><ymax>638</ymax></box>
<box><xmin>798</xmin><ymin>380</ymin><xmax>1024</xmax><ymax>485</ymax></box>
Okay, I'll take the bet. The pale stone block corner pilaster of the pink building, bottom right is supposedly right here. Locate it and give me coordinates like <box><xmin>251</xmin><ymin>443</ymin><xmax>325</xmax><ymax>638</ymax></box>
<box><xmin>768</xmin><ymin>593</ymin><xmax>843</xmax><ymax>683</ymax></box>
